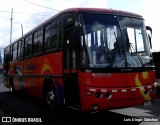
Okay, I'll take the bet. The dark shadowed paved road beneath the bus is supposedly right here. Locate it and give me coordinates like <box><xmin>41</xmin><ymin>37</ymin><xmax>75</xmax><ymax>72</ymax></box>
<box><xmin>0</xmin><ymin>81</ymin><xmax>160</xmax><ymax>125</ymax></box>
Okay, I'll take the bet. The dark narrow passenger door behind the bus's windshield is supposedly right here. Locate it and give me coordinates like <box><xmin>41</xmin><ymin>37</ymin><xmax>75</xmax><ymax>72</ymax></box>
<box><xmin>63</xmin><ymin>27</ymin><xmax>79</xmax><ymax>106</ymax></box>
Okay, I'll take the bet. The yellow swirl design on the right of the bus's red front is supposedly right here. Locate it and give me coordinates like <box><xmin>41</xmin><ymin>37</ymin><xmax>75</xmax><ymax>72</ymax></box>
<box><xmin>135</xmin><ymin>72</ymin><xmax>151</xmax><ymax>100</ymax></box>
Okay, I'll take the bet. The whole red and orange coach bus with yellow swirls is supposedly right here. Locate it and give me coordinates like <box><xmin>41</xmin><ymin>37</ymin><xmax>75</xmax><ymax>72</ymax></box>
<box><xmin>4</xmin><ymin>8</ymin><xmax>156</xmax><ymax>112</ymax></box>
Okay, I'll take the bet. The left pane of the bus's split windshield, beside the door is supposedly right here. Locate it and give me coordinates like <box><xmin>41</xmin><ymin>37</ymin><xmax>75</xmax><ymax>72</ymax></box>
<box><xmin>81</xmin><ymin>14</ymin><xmax>125</xmax><ymax>68</ymax></box>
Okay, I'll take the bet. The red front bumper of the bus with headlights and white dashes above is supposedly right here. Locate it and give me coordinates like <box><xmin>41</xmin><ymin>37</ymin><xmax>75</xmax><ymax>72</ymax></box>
<box><xmin>80</xmin><ymin>84</ymin><xmax>156</xmax><ymax>112</ymax></box>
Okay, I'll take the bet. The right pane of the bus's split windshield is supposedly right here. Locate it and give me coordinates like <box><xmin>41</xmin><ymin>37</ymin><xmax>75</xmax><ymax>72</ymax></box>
<box><xmin>119</xmin><ymin>17</ymin><xmax>153</xmax><ymax>67</ymax></box>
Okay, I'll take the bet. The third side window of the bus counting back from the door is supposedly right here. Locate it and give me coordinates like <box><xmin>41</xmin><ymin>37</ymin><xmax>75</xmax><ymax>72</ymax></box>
<box><xmin>24</xmin><ymin>35</ymin><xmax>32</xmax><ymax>57</ymax></box>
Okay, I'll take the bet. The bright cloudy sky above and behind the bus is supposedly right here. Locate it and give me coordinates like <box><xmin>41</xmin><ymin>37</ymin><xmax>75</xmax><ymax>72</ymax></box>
<box><xmin>0</xmin><ymin>0</ymin><xmax>160</xmax><ymax>51</ymax></box>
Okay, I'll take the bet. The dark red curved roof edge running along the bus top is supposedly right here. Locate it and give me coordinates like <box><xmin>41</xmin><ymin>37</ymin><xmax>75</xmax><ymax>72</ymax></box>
<box><xmin>5</xmin><ymin>8</ymin><xmax>142</xmax><ymax>48</ymax></box>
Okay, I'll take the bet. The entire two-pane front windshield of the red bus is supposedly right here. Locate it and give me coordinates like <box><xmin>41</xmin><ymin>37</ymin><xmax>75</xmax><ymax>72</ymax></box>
<box><xmin>79</xmin><ymin>13</ymin><xmax>153</xmax><ymax>68</ymax></box>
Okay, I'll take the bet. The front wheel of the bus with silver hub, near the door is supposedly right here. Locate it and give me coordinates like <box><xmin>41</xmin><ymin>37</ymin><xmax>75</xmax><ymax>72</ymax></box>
<box><xmin>43</xmin><ymin>83</ymin><xmax>57</xmax><ymax>110</ymax></box>
